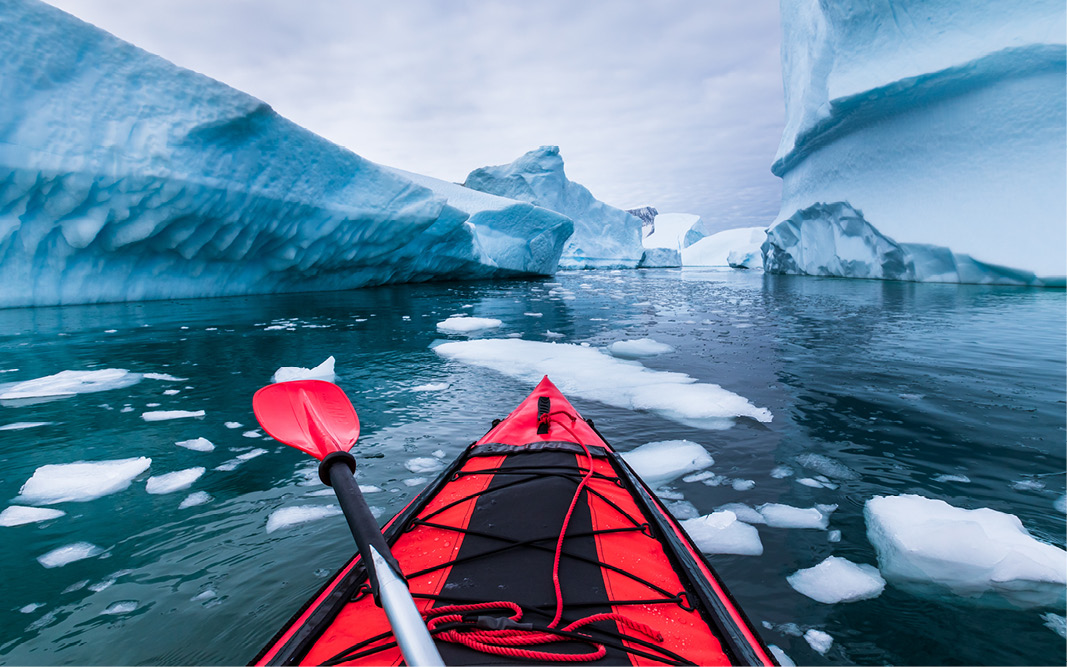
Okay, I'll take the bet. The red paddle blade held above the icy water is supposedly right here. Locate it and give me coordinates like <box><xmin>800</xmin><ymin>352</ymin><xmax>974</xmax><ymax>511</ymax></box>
<box><xmin>252</xmin><ymin>380</ymin><xmax>360</xmax><ymax>461</ymax></box>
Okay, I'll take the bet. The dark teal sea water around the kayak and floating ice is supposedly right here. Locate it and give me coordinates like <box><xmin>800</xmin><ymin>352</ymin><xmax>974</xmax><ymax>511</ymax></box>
<box><xmin>0</xmin><ymin>270</ymin><xmax>1067</xmax><ymax>665</ymax></box>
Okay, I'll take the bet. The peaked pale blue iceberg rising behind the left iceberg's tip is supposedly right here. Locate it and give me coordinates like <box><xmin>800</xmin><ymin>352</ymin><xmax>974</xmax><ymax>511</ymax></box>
<box><xmin>463</xmin><ymin>146</ymin><xmax>643</xmax><ymax>269</ymax></box>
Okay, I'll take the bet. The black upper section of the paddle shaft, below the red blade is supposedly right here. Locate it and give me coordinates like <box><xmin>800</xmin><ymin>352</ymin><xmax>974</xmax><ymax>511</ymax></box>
<box><xmin>319</xmin><ymin>451</ymin><xmax>403</xmax><ymax>606</ymax></box>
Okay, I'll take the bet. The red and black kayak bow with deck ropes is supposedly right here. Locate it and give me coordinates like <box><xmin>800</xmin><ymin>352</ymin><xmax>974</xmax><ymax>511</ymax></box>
<box><xmin>253</xmin><ymin>378</ymin><xmax>776</xmax><ymax>665</ymax></box>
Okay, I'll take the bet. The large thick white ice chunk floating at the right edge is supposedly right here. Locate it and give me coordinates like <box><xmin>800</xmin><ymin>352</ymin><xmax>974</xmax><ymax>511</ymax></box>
<box><xmin>863</xmin><ymin>495</ymin><xmax>1067</xmax><ymax>607</ymax></box>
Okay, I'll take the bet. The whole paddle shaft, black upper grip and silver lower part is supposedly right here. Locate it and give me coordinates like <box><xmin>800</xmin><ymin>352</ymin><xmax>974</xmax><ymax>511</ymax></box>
<box><xmin>322</xmin><ymin>458</ymin><xmax>445</xmax><ymax>667</ymax></box>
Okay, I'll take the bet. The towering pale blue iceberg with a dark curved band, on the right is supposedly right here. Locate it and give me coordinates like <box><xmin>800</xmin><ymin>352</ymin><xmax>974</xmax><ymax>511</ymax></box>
<box><xmin>763</xmin><ymin>0</ymin><xmax>1067</xmax><ymax>286</ymax></box>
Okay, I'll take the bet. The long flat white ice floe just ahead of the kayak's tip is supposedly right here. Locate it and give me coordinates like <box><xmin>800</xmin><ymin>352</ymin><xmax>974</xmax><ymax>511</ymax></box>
<box><xmin>433</xmin><ymin>338</ymin><xmax>771</xmax><ymax>429</ymax></box>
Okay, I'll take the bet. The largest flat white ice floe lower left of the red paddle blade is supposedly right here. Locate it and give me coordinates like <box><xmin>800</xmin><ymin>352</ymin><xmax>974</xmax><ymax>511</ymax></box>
<box><xmin>18</xmin><ymin>457</ymin><xmax>152</xmax><ymax>505</ymax></box>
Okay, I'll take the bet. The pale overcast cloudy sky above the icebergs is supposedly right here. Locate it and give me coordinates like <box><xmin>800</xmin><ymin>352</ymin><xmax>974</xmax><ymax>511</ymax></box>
<box><xmin>43</xmin><ymin>0</ymin><xmax>784</xmax><ymax>227</ymax></box>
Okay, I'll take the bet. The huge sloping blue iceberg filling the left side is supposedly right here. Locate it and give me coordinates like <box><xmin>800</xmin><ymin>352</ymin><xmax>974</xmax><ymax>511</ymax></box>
<box><xmin>0</xmin><ymin>0</ymin><xmax>573</xmax><ymax>307</ymax></box>
